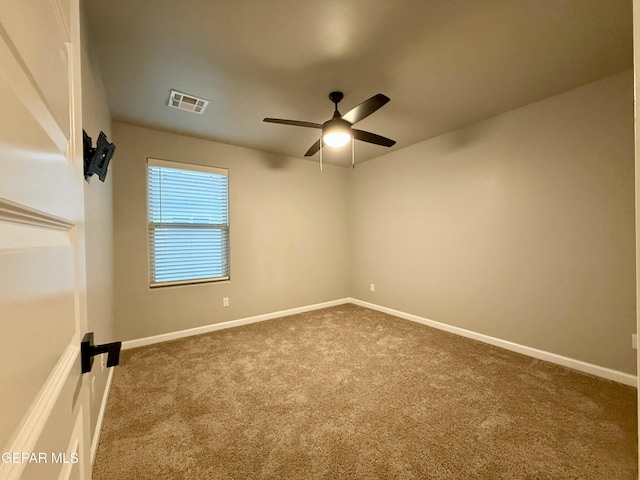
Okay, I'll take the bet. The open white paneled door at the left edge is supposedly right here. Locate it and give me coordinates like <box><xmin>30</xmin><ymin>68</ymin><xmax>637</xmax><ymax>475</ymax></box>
<box><xmin>0</xmin><ymin>0</ymin><xmax>90</xmax><ymax>479</ymax></box>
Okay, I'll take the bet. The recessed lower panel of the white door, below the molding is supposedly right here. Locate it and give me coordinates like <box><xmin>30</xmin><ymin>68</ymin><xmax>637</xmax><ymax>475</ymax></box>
<box><xmin>0</xmin><ymin>246</ymin><xmax>75</xmax><ymax>445</ymax></box>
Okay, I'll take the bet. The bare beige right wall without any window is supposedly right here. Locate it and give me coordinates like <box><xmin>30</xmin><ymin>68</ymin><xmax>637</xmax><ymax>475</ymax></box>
<box><xmin>349</xmin><ymin>71</ymin><xmax>636</xmax><ymax>373</ymax></box>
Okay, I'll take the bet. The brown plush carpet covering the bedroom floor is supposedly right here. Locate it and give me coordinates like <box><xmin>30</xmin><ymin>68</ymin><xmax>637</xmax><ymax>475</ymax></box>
<box><xmin>93</xmin><ymin>305</ymin><xmax>637</xmax><ymax>480</ymax></box>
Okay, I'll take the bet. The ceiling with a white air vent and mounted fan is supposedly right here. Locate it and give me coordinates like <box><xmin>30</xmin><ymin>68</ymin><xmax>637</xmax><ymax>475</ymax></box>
<box><xmin>84</xmin><ymin>0</ymin><xmax>633</xmax><ymax>165</ymax></box>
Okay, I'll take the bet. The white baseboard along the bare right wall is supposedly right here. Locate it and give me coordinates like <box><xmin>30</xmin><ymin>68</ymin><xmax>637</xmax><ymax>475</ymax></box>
<box><xmin>349</xmin><ymin>298</ymin><xmax>638</xmax><ymax>388</ymax></box>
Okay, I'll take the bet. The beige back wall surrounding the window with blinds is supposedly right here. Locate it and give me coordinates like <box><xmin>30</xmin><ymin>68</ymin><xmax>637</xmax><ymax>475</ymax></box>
<box><xmin>113</xmin><ymin>124</ymin><xmax>349</xmax><ymax>340</ymax></box>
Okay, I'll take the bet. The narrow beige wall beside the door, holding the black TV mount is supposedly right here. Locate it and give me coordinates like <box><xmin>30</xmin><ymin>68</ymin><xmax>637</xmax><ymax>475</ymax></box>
<box><xmin>81</xmin><ymin>0</ymin><xmax>117</xmax><ymax>452</ymax></box>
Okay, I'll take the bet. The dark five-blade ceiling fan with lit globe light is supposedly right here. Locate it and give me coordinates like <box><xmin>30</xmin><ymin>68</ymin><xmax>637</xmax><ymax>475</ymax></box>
<box><xmin>264</xmin><ymin>92</ymin><xmax>396</xmax><ymax>161</ymax></box>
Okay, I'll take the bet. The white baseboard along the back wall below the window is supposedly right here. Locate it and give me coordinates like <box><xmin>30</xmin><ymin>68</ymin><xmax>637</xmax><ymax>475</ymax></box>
<box><xmin>122</xmin><ymin>298</ymin><xmax>351</xmax><ymax>350</ymax></box>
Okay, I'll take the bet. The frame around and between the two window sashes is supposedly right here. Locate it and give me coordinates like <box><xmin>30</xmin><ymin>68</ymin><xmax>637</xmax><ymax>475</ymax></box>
<box><xmin>145</xmin><ymin>157</ymin><xmax>231</xmax><ymax>289</ymax></box>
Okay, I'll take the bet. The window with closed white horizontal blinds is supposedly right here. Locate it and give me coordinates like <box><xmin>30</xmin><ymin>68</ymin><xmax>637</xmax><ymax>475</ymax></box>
<box><xmin>147</xmin><ymin>158</ymin><xmax>229</xmax><ymax>287</ymax></box>
